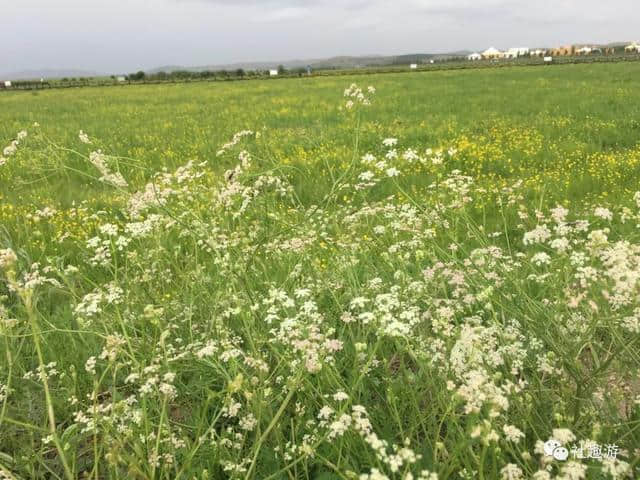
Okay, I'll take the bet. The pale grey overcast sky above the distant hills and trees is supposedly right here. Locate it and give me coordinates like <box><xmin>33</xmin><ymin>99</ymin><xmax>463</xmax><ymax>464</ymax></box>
<box><xmin>0</xmin><ymin>0</ymin><xmax>640</xmax><ymax>73</ymax></box>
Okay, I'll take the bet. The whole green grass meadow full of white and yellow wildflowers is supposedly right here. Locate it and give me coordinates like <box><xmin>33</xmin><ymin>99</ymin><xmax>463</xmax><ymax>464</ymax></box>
<box><xmin>0</xmin><ymin>63</ymin><xmax>640</xmax><ymax>480</ymax></box>
